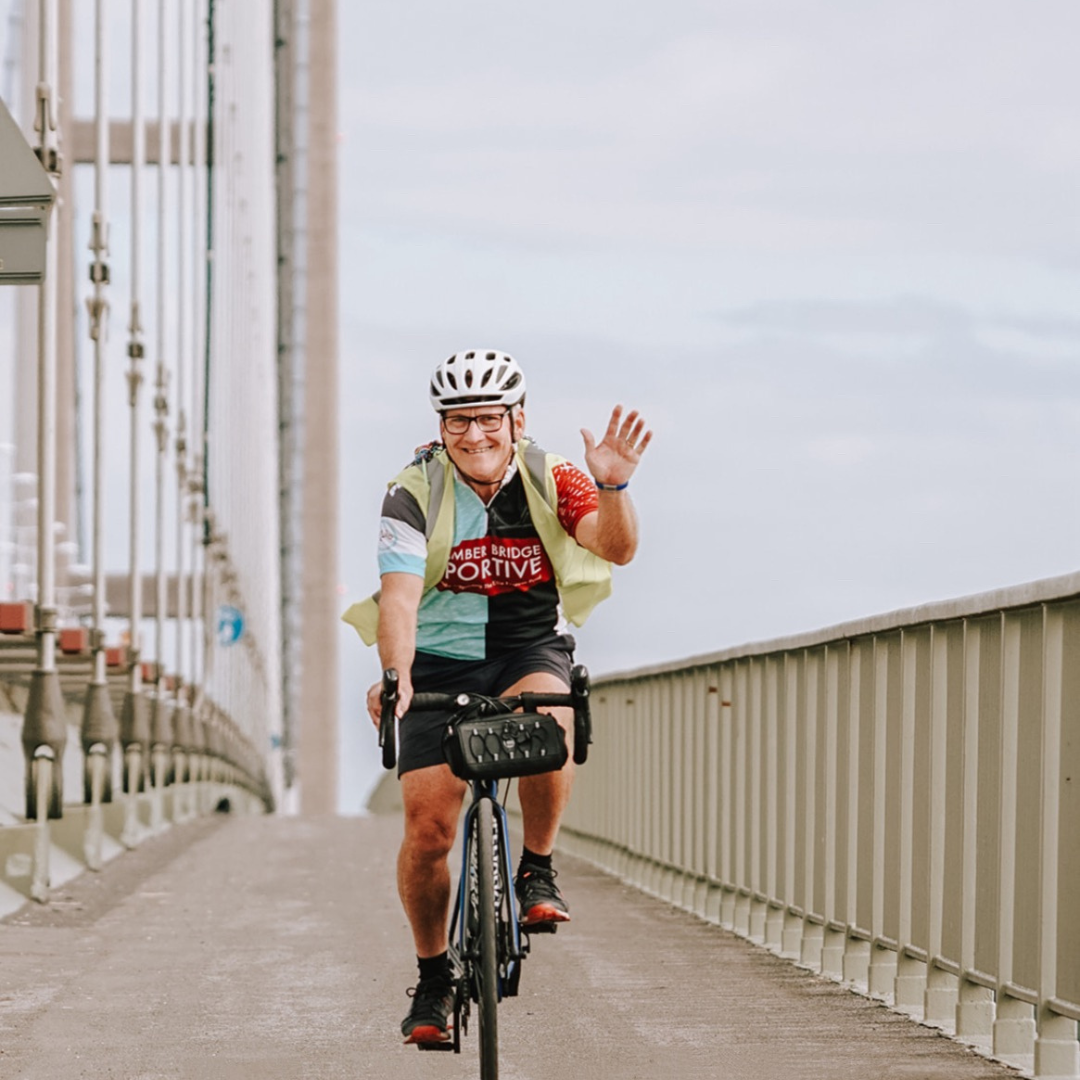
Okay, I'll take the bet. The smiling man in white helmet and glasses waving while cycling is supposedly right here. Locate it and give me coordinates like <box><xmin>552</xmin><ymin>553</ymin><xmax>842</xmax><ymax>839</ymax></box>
<box><xmin>343</xmin><ymin>350</ymin><xmax>651</xmax><ymax>1043</ymax></box>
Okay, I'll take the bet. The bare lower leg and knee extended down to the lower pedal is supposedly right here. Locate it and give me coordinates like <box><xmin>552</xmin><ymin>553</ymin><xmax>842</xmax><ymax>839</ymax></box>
<box><xmin>397</xmin><ymin>765</ymin><xmax>465</xmax><ymax>957</ymax></box>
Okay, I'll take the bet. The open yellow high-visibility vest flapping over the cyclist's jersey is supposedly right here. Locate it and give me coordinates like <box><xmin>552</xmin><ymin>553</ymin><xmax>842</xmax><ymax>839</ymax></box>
<box><xmin>341</xmin><ymin>438</ymin><xmax>611</xmax><ymax>645</ymax></box>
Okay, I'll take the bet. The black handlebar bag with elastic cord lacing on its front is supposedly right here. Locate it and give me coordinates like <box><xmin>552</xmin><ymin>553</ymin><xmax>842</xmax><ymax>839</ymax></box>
<box><xmin>443</xmin><ymin>713</ymin><xmax>569</xmax><ymax>780</ymax></box>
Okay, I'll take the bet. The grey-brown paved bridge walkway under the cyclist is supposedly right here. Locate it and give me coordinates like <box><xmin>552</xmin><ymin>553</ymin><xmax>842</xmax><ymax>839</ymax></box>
<box><xmin>0</xmin><ymin>815</ymin><xmax>1015</xmax><ymax>1080</ymax></box>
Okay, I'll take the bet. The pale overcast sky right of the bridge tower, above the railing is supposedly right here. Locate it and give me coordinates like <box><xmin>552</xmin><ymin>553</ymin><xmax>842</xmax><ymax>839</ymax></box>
<box><xmin>339</xmin><ymin>0</ymin><xmax>1080</xmax><ymax>805</ymax></box>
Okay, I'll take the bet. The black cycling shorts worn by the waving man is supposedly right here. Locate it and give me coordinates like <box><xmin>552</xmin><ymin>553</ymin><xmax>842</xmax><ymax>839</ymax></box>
<box><xmin>397</xmin><ymin>633</ymin><xmax>577</xmax><ymax>777</ymax></box>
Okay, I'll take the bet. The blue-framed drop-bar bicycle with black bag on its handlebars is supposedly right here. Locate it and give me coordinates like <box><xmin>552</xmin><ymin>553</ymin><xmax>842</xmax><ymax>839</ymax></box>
<box><xmin>379</xmin><ymin>664</ymin><xmax>592</xmax><ymax>1080</ymax></box>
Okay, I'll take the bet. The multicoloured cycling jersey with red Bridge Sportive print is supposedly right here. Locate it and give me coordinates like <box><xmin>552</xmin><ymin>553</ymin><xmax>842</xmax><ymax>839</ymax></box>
<box><xmin>379</xmin><ymin>451</ymin><xmax>597</xmax><ymax>660</ymax></box>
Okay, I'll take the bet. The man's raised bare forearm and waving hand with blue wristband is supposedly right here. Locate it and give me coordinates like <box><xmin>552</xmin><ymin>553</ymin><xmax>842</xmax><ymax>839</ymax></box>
<box><xmin>575</xmin><ymin>405</ymin><xmax>652</xmax><ymax>566</ymax></box>
